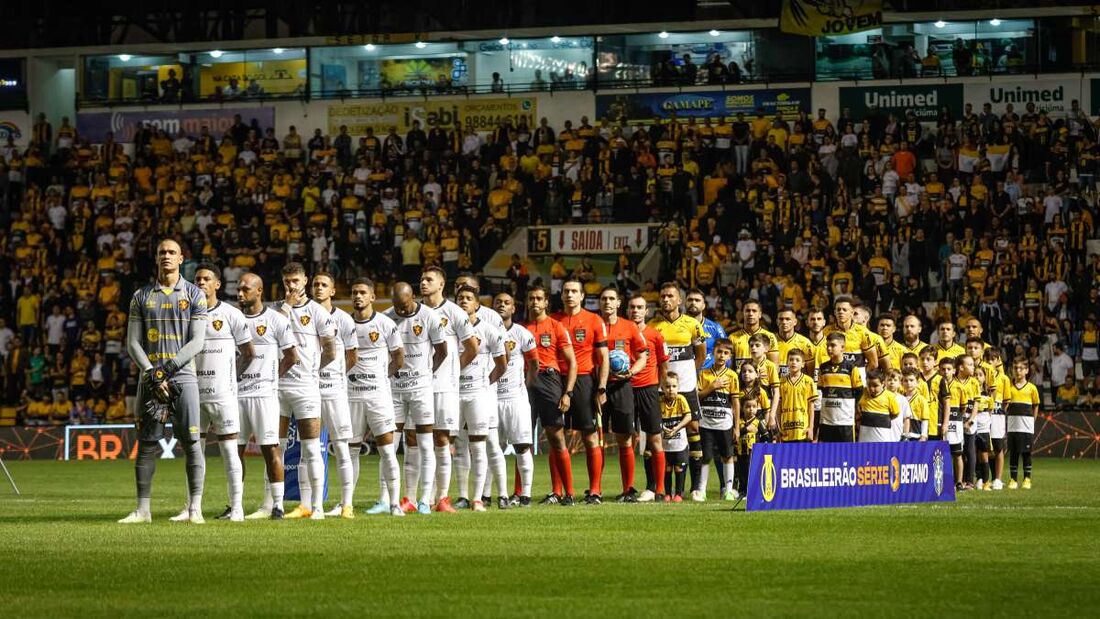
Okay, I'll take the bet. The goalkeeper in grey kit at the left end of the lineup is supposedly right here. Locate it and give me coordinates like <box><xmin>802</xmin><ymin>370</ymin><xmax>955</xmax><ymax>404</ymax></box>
<box><xmin>119</xmin><ymin>239</ymin><xmax>209</xmax><ymax>524</ymax></box>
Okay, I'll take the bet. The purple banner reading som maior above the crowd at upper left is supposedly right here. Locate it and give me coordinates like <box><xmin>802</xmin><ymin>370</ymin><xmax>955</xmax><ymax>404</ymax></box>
<box><xmin>76</xmin><ymin>108</ymin><xmax>275</xmax><ymax>143</ymax></box>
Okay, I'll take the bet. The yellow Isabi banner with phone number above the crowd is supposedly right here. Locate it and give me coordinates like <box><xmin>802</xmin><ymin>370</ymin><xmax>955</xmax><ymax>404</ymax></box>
<box><xmin>329</xmin><ymin>97</ymin><xmax>538</xmax><ymax>136</ymax></box>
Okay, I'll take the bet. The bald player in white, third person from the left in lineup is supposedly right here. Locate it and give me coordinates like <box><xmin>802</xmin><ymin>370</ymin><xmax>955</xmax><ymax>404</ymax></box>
<box><xmin>237</xmin><ymin>273</ymin><xmax>298</xmax><ymax>520</ymax></box>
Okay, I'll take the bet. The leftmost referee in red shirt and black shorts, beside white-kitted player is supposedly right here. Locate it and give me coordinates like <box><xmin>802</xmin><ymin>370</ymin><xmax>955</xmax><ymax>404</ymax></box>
<box><xmin>526</xmin><ymin>286</ymin><xmax>576</xmax><ymax>506</ymax></box>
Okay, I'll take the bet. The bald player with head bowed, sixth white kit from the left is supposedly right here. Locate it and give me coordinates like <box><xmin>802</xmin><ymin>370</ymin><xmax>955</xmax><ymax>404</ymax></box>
<box><xmin>385</xmin><ymin>281</ymin><xmax>446</xmax><ymax>515</ymax></box>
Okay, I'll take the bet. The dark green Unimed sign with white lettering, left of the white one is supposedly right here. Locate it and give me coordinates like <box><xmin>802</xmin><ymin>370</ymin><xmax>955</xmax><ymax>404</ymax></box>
<box><xmin>840</xmin><ymin>84</ymin><xmax>963</xmax><ymax>122</ymax></box>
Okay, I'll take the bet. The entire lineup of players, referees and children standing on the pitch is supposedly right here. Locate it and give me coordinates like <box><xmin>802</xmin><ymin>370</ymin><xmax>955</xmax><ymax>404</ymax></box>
<box><xmin>121</xmin><ymin>241</ymin><xmax>1038</xmax><ymax>522</ymax></box>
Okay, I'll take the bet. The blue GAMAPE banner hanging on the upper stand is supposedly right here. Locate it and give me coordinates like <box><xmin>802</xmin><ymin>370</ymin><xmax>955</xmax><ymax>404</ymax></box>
<box><xmin>596</xmin><ymin>88</ymin><xmax>810</xmax><ymax>124</ymax></box>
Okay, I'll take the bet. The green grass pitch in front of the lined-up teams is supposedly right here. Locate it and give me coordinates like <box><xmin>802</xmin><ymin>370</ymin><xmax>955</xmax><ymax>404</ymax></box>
<box><xmin>0</xmin><ymin>457</ymin><xmax>1100</xmax><ymax>618</ymax></box>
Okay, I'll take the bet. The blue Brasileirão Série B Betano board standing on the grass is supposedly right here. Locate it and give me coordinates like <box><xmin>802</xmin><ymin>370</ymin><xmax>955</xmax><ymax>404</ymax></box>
<box><xmin>746</xmin><ymin>441</ymin><xmax>955</xmax><ymax>510</ymax></box>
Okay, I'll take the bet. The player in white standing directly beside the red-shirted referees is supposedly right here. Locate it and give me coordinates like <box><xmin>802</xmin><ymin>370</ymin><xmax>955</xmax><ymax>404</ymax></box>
<box><xmin>493</xmin><ymin>292</ymin><xmax>539</xmax><ymax>507</ymax></box>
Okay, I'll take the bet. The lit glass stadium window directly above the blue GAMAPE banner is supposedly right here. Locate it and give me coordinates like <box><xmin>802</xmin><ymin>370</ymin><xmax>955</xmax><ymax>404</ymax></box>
<box><xmin>596</xmin><ymin>31</ymin><xmax>756</xmax><ymax>88</ymax></box>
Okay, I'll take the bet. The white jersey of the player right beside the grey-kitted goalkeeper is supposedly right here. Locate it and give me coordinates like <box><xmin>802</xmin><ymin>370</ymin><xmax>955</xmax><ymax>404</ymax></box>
<box><xmin>195</xmin><ymin>302</ymin><xmax>252</xmax><ymax>402</ymax></box>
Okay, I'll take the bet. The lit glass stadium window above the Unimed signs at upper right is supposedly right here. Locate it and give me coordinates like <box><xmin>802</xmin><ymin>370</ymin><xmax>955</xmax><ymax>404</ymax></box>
<box><xmin>816</xmin><ymin>20</ymin><xmax>1035</xmax><ymax>80</ymax></box>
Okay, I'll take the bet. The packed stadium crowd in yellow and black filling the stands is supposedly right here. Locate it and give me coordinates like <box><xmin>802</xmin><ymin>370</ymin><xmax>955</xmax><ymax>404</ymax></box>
<box><xmin>0</xmin><ymin>93</ymin><xmax>1100</xmax><ymax>435</ymax></box>
